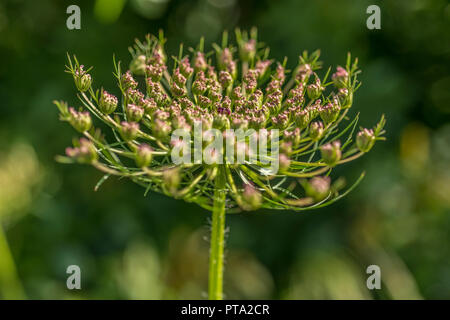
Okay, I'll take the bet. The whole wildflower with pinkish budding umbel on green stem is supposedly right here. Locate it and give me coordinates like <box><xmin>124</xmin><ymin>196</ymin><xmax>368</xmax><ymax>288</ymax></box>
<box><xmin>55</xmin><ymin>30</ymin><xmax>385</xmax><ymax>299</ymax></box>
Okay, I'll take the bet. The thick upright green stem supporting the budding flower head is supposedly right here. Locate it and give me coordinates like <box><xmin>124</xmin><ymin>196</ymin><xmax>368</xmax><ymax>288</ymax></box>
<box><xmin>208</xmin><ymin>168</ymin><xmax>227</xmax><ymax>300</ymax></box>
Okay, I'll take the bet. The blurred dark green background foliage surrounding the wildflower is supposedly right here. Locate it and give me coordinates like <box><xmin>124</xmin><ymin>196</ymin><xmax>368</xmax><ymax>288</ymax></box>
<box><xmin>0</xmin><ymin>0</ymin><xmax>450</xmax><ymax>299</ymax></box>
